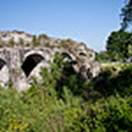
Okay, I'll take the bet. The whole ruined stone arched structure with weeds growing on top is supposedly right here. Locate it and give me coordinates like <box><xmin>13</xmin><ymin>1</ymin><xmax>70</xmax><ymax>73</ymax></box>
<box><xmin>0</xmin><ymin>31</ymin><xmax>100</xmax><ymax>91</ymax></box>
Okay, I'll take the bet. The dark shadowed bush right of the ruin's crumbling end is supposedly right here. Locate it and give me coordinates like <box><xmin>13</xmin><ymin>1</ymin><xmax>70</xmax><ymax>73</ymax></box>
<box><xmin>86</xmin><ymin>65</ymin><xmax>132</xmax><ymax>99</ymax></box>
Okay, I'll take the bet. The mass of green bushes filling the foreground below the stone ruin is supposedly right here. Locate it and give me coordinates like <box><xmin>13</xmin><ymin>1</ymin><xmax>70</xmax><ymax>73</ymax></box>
<box><xmin>0</xmin><ymin>54</ymin><xmax>132</xmax><ymax>132</ymax></box>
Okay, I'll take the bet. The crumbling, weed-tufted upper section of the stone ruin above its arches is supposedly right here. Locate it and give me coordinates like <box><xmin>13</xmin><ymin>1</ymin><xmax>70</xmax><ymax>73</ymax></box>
<box><xmin>0</xmin><ymin>30</ymin><xmax>94</xmax><ymax>54</ymax></box>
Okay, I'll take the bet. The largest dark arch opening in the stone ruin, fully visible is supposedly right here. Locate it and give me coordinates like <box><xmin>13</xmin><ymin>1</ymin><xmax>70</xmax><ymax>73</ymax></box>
<box><xmin>22</xmin><ymin>53</ymin><xmax>44</xmax><ymax>77</ymax></box>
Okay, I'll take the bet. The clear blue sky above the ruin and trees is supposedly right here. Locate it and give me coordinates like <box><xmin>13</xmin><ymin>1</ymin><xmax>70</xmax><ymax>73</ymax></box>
<box><xmin>0</xmin><ymin>0</ymin><xmax>125</xmax><ymax>51</ymax></box>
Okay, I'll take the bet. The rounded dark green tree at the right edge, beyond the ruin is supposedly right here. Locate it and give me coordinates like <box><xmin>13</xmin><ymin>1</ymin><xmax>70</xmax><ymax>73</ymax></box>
<box><xmin>106</xmin><ymin>31</ymin><xmax>132</xmax><ymax>61</ymax></box>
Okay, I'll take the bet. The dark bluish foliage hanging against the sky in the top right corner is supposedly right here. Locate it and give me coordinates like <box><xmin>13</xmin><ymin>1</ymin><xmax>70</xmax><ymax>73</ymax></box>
<box><xmin>121</xmin><ymin>0</ymin><xmax>132</xmax><ymax>31</ymax></box>
